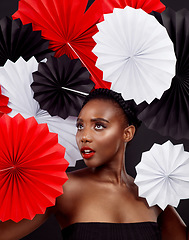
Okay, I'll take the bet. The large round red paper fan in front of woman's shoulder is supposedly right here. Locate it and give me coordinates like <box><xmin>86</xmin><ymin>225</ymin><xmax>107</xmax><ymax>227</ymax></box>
<box><xmin>0</xmin><ymin>114</ymin><xmax>68</xmax><ymax>222</ymax></box>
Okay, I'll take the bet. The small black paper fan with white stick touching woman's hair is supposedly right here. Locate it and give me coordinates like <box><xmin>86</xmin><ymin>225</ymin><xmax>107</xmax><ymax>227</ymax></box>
<box><xmin>31</xmin><ymin>54</ymin><xmax>94</xmax><ymax>119</ymax></box>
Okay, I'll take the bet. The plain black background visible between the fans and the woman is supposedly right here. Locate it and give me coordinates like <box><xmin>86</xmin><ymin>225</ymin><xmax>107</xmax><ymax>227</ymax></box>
<box><xmin>0</xmin><ymin>0</ymin><xmax>189</xmax><ymax>240</ymax></box>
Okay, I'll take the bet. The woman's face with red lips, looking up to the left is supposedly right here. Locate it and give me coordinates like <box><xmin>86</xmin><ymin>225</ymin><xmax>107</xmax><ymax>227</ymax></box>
<box><xmin>76</xmin><ymin>99</ymin><xmax>133</xmax><ymax>167</ymax></box>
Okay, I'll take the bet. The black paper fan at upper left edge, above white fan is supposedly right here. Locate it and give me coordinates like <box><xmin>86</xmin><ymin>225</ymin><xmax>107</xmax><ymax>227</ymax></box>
<box><xmin>0</xmin><ymin>17</ymin><xmax>54</xmax><ymax>66</ymax></box>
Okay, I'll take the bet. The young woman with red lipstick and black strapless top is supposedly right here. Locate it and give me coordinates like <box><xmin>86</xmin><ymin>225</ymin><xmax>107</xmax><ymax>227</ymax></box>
<box><xmin>0</xmin><ymin>89</ymin><xmax>187</xmax><ymax>240</ymax></box>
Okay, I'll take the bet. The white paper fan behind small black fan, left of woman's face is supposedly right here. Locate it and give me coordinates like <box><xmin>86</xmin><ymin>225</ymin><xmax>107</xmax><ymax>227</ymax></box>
<box><xmin>0</xmin><ymin>57</ymin><xmax>81</xmax><ymax>166</ymax></box>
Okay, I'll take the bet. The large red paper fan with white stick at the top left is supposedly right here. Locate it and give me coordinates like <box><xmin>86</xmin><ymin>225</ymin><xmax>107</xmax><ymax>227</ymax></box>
<box><xmin>13</xmin><ymin>0</ymin><xmax>110</xmax><ymax>88</ymax></box>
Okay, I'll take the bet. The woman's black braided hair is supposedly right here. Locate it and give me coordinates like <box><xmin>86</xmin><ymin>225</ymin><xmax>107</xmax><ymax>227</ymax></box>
<box><xmin>83</xmin><ymin>88</ymin><xmax>141</xmax><ymax>129</ymax></box>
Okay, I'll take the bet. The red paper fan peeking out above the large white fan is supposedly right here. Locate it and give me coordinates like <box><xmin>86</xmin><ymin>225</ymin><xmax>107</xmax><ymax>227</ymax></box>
<box><xmin>101</xmin><ymin>0</ymin><xmax>165</xmax><ymax>13</ymax></box>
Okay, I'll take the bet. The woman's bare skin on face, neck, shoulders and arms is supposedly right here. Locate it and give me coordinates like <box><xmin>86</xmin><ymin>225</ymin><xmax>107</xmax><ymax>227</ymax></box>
<box><xmin>0</xmin><ymin>99</ymin><xmax>189</xmax><ymax>240</ymax></box>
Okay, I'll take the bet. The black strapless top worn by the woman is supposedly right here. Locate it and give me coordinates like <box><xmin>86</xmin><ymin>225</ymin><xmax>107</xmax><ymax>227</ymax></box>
<box><xmin>62</xmin><ymin>222</ymin><xmax>161</xmax><ymax>240</ymax></box>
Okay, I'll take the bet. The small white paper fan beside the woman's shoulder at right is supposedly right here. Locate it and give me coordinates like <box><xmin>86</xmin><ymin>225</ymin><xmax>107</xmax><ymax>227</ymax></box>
<box><xmin>135</xmin><ymin>141</ymin><xmax>189</xmax><ymax>210</ymax></box>
